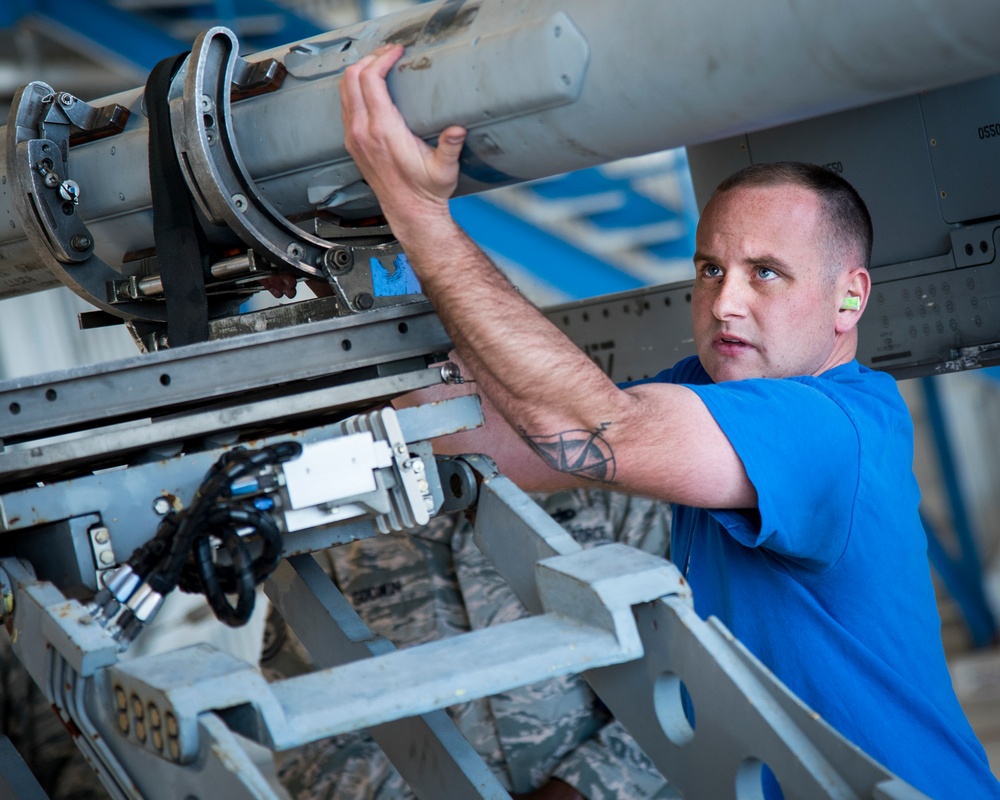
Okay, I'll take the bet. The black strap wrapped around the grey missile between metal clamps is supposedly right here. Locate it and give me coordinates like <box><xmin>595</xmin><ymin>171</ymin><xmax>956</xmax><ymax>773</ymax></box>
<box><xmin>146</xmin><ymin>53</ymin><xmax>208</xmax><ymax>347</ymax></box>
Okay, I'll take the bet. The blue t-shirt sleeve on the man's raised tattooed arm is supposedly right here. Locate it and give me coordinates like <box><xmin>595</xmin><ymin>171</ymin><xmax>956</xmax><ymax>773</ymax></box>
<box><xmin>690</xmin><ymin>378</ymin><xmax>861</xmax><ymax>571</ymax></box>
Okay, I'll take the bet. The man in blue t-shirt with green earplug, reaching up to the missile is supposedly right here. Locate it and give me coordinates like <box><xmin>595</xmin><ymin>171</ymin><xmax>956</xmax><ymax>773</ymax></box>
<box><xmin>341</xmin><ymin>46</ymin><xmax>1000</xmax><ymax>798</ymax></box>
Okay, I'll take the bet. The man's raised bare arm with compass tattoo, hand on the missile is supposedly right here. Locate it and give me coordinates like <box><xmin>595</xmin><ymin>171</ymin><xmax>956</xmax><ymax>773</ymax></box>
<box><xmin>340</xmin><ymin>45</ymin><xmax>756</xmax><ymax>507</ymax></box>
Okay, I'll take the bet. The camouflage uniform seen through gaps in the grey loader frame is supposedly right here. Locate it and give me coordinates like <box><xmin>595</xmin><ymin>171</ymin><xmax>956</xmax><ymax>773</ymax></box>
<box><xmin>279</xmin><ymin>490</ymin><xmax>676</xmax><ymax>800</ymax></box>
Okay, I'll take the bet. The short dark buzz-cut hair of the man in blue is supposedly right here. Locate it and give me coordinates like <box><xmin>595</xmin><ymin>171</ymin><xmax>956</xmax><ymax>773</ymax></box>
<box><xmin>715</xmin><ymin>161</ymin><xmax>872</xmax><ymax>268</ymax></box>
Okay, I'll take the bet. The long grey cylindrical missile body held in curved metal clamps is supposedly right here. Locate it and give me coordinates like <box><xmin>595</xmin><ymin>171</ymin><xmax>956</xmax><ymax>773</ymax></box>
<box><xmin>0</xmin><ymin>0</ymin><xmax>1000</xmax><ymax>318</ymax></box>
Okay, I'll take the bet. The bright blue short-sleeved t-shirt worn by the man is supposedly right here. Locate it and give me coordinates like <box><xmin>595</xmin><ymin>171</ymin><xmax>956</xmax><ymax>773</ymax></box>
<box><xmin>625</xmin><ymin>357</ymin><xmax>1000</xmax><ymax>800</ymax></box>
